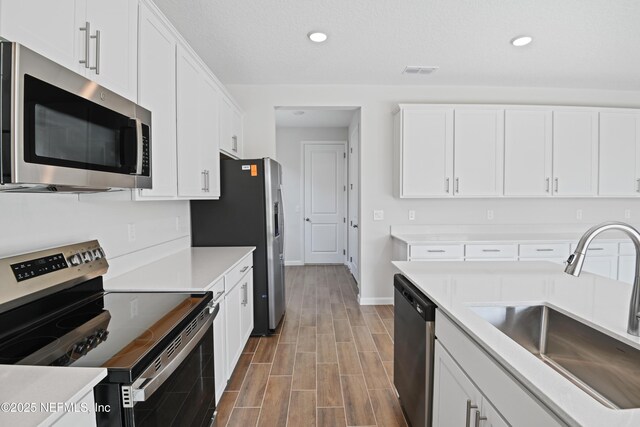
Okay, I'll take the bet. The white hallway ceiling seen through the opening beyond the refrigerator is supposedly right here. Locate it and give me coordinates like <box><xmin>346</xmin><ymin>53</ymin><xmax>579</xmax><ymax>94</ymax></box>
<box><xmin>276</xmin><ymin>108</ymin><xmax>354</xmax><ymax>128</ymax></box>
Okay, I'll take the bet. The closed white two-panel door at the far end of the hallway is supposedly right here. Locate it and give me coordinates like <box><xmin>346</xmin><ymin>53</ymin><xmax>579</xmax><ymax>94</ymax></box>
<box><xmin>304</xmin><ymin>143</ymin><xmax>346</xmax><ymax>264</ymax></box>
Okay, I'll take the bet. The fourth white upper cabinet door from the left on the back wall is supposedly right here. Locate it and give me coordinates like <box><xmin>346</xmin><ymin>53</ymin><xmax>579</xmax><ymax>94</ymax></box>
<box><xmin>553</xmin><ymin>111</ymin><xmax>598</xmax><ymax>196</ymax></box>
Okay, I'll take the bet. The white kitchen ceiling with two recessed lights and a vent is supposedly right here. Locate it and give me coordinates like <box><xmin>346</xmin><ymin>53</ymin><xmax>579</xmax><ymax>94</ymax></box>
<box><xmin>155</xmin><ymin>0</ymin><xmax>640</xmax><ymax>90</ymax></box>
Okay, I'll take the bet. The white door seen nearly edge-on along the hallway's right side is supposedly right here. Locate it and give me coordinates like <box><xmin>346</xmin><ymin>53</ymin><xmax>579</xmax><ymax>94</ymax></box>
<box><xmin>347</xmin><ymin>126</ymin><xmax>360</xmax><ymax>282</ymax></box>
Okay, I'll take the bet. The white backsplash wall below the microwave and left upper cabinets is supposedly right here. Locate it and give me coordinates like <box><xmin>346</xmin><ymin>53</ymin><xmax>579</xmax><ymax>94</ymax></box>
<box><xmin>0</xmin><ymin>192</ymin><xmax>191</xmax><ymax>273</ymax></box>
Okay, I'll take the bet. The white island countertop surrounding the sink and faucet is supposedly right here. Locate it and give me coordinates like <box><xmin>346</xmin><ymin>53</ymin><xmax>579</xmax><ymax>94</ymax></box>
<box><xmin>393</xmin><ymin>261</ymin><xmax>640</xmax><ymax>426</ymax></box>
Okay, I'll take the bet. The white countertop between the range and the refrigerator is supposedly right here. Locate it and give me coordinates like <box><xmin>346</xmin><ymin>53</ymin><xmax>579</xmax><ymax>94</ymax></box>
<box><xmin>104</xmin><ymin>246</ymin><xmax>255</xmax><ymax>292</ymax></box>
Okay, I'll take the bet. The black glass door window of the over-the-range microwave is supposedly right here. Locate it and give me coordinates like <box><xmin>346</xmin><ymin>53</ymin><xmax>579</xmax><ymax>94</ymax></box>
<box><xmin>24</xmin><ymin>74</ymin><xmax>138</xmax><ymax>174</ymax></box>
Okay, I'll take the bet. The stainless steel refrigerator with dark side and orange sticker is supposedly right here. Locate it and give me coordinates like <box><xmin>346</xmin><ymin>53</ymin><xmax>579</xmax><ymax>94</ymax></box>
<box><xmin>191</xmin><ymin>158</ymin><xmax>285</xmax><ymax>335</ymax></box>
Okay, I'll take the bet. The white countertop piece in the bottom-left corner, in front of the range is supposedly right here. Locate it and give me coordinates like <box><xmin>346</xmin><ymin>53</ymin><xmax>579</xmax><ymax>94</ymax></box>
<box><xmin>0</xmin><ymin>365</ymin><xmax>107</xmax><ymax>427</ymax></box>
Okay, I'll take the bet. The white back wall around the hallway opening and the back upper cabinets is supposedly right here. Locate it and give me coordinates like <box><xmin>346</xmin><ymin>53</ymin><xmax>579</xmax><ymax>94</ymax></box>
<box><xmin>228</xmin><ymin>85</ymin><xmax>640</xmax><ymax>302</ymax></box>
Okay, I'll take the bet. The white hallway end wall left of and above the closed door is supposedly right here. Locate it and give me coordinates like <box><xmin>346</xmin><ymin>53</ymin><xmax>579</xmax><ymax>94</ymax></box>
<box><xmin>276</xmin><ymin>127</ymin><xmax>348</xmax><ymax>265</ymax></box>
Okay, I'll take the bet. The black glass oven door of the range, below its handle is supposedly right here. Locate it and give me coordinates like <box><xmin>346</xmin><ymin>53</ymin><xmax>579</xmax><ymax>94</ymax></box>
<box><xmin>128</xmin><ymin>325</ymin><xmax>216</xmax><ymax>427</ymax></box>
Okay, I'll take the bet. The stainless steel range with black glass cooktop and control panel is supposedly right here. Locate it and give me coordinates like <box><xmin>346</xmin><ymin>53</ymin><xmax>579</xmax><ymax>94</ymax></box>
<box><xmin>0</xmin><ymin>240</ymin><xmax>217</xmax><ymax>426</ymax></box>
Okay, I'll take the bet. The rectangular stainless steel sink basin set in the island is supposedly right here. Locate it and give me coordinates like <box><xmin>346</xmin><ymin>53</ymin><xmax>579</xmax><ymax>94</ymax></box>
<box><xmin>471</xmin><ymin>305</ymin><xmax>640</xmax><ymax>409</ymax></box>
